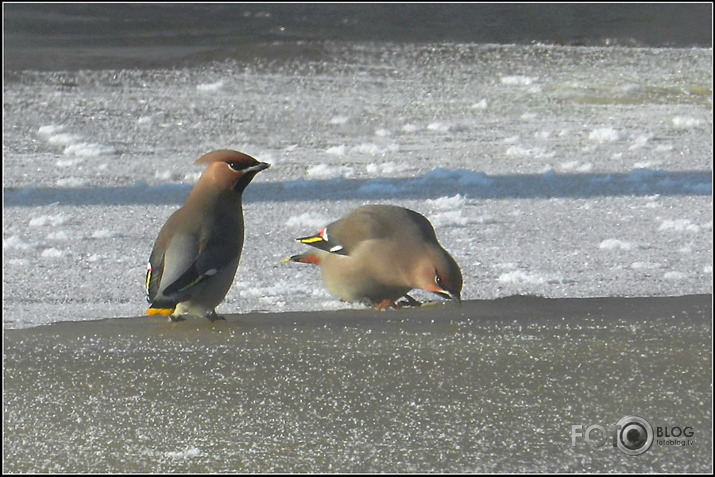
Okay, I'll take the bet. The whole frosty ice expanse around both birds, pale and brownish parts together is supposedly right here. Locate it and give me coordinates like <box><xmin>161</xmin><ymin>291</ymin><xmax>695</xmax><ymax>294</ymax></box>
<box><xmin>3</xmin><ymin>42</ymin><xmax>713</xmax><ymax>472</ymax></box>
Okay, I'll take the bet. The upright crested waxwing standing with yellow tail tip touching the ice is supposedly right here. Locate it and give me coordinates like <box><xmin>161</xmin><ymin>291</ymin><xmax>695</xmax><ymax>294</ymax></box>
<box><xmin>146</xmin><ymin>150</ymin><xmax>270</xmax><ymax>321</ymax></box>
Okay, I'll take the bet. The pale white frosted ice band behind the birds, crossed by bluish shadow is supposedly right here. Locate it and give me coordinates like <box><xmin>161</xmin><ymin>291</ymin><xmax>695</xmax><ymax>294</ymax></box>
<box><xmin>3</xmin><ymin>42</ymin><xmax>713</xmax><ymax>328</ymax></box>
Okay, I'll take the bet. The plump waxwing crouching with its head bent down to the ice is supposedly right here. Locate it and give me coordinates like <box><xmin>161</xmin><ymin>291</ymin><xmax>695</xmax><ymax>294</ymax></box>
<box><xmin>284</xmin><ymin>205</ymin><xmax>462</xmax><ymax>310</ymax></box>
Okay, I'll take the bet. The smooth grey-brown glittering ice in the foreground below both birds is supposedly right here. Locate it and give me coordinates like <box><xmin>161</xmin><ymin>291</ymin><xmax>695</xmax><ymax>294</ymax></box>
<box><xmin>4</xmin><ymin>296</ymin><xmax>712</xmax><ymax>473</ymax></box>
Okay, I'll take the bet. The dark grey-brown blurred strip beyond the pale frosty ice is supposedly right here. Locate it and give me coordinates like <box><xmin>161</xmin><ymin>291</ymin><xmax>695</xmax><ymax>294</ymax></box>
<box><xmin>3</xmin><ymin>3</ymin><xmax>712</xmax><ymax>70</ymax></box>
